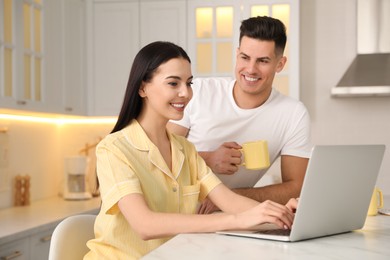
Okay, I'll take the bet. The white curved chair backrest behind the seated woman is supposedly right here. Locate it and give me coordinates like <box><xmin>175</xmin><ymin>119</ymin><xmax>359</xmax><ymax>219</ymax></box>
<box><xmin>49</xmin><ymin>215</ymin><xmax>96</xmax><ymax>260</ymax></box>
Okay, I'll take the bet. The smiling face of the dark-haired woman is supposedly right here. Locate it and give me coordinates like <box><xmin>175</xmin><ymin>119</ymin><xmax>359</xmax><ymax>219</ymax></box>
<box><xmin>139</xmin><ymin>58</ymin><xmax>193</xmax><ymax>120</ymax></box>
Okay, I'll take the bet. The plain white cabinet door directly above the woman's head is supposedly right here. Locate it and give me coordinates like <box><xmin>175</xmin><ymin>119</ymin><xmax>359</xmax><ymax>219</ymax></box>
<box><xmin>140</xmin><ymin>0</ymin><xmax>187</xmax><ymax>49</ymax></box>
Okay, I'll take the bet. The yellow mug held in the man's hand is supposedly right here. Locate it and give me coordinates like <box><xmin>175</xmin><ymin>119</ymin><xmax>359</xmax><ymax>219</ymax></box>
<box><xmin>240</xmin><ymin>140</ymin><xmax>270</xmax><ymax>170</ymax></box>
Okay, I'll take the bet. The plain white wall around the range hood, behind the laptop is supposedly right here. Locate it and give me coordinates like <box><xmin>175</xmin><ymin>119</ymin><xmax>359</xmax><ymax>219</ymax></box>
<box><xmin>300</xmin><ymin>0</ymin><xmax>390</xmax><ymax>195</ymax></box>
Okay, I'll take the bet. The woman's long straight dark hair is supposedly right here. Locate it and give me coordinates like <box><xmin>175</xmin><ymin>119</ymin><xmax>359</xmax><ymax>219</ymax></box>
<box><xmin>111</xmin><ymin>41</ymin><xmax>191</xmax><ymax>133</ymax></box>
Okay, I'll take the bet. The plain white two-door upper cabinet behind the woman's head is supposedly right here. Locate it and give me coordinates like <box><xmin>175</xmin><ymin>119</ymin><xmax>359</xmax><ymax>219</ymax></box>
<box><xmin>87</xmin><ymin>0</ymin><xmax>186</xmax><ymax>116</ymax></box>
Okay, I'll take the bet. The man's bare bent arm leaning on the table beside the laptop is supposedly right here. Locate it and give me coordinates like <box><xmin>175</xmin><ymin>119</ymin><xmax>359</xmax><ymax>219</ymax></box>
<box><xmin>234</xmin><ymin>155</ymin><xmax>309</xmax><ymax>204</ymax></box>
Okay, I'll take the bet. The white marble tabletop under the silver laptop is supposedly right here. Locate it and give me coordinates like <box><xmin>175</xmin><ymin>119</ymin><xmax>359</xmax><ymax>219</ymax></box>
<box><xmin>142</xmin><ymin>197</ymin><xmax>390</xmax><ymax>260</ymax></box>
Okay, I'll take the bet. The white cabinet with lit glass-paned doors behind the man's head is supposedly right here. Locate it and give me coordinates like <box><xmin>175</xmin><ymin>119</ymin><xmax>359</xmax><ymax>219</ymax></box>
<box><xmin>187</xmin><ymin>0</ymin><xmax>299</xmax><ymax>99</ymax></box>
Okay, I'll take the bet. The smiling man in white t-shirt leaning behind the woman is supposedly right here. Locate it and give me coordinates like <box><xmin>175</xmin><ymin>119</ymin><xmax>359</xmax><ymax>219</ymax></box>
<box><xmin>168</xmin><ymin>17</ymin><xmax>311</xmax><ymax>213</ymax></box>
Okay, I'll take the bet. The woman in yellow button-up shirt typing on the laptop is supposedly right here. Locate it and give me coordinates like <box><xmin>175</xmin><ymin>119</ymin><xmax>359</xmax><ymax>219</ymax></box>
<box><xmin>84</xmin><ymin>42</ymin><xmax>296</xmax><ymax>259</ymax></box>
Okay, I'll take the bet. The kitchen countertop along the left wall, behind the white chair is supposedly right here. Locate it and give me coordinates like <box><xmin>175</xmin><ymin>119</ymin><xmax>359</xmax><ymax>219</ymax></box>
<box><xmin>0</xmin><ymin>197</ymin><xmax>100</xmax><ymax>244</ymax></box>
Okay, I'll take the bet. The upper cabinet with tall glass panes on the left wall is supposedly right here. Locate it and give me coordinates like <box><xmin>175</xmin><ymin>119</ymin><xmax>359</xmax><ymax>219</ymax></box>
<box><xmin>0</xmin><ymin>0</ymin><xmax>86</xmax><ymax>114</ymax></box>
